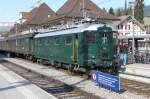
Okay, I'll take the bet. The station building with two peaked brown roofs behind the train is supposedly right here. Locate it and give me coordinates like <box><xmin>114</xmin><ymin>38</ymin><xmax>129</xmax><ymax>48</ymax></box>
<box><xmin>9</xmin><ymin>0</ymin><xmax>119</xmax><ymax>35</ymax></box>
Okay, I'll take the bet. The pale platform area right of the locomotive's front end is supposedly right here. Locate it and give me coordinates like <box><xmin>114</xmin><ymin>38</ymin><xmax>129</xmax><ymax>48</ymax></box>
<box><xmin>120</xmin><ymin>63</ymin><xmax>150</xmax><ymax>84</ymax></box>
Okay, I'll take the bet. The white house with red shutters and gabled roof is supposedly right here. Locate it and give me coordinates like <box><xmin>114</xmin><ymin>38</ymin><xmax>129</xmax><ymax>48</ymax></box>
<box><xmin>113</xmin><ymin>15</ymin><xmax>146</xmax><ymax>36</ymax></box>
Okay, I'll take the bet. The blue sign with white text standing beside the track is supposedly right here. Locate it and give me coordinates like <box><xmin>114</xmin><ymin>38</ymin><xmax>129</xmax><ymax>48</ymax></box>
<box><xmin>92</xmin><ymin>71</ymin><xmax>120</xmax><ymax>92</ymax></box>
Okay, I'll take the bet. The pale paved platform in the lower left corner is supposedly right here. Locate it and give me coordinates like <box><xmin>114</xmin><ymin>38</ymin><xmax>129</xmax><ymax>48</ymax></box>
<box><xmin>0</xmin><ymin>64</ymin><xmax>57</xmax><ymax>99</ymax></box>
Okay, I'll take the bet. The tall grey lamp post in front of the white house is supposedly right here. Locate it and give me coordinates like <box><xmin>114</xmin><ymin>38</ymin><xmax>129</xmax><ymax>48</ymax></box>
<box><xmin>129</xmin><ymin>2</ymin><xmax>135</xmax><ymax>63</ymax></box>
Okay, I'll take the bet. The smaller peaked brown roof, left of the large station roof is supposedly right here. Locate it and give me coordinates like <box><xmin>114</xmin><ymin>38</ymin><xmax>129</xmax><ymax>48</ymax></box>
<box><xmin>26</xmin><ymin>3</ymin><xmax>55</xmax><ymax>25</ymax></box>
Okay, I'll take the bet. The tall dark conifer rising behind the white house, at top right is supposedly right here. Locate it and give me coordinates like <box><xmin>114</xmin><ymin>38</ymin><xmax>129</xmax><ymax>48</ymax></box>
<box><xmin>134</xmin><ymin>0</ymin><xmax>144</xmax><ymax>23</ymax></box>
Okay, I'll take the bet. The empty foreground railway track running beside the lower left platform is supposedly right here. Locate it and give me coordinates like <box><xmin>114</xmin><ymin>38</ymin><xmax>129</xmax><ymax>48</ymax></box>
<box><xmin>0</xmin><ymin>60</ymin><xmax>100</xmax><ymax>99</ymax></box>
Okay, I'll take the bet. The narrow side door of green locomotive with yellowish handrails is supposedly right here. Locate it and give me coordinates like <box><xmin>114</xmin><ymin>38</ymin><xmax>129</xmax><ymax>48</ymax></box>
<box><xmin>72</xmin><ymin>34</ymin><xmax>79</xmax><ymax>63</ymax></box>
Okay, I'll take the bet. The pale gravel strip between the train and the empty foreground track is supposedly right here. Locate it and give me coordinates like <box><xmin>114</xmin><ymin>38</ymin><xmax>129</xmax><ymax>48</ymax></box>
<box><xmin>4</xmin><ymin>58</ymin><xmax>147</xmax><ymax>99</ymax></box>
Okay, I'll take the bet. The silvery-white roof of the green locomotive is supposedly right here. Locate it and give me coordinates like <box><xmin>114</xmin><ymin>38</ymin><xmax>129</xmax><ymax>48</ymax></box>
<box><xmin>35</xmin><ymin>24</ymin><xmax>117</xmax><ymax>38</ymax></box>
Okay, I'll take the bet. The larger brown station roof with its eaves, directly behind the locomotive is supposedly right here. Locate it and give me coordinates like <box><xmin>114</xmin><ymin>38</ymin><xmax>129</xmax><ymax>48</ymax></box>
<box><xmin>40</xmin><ymin>0</ymin><xmax>119</xmax><ymax>26</ymax></box>
